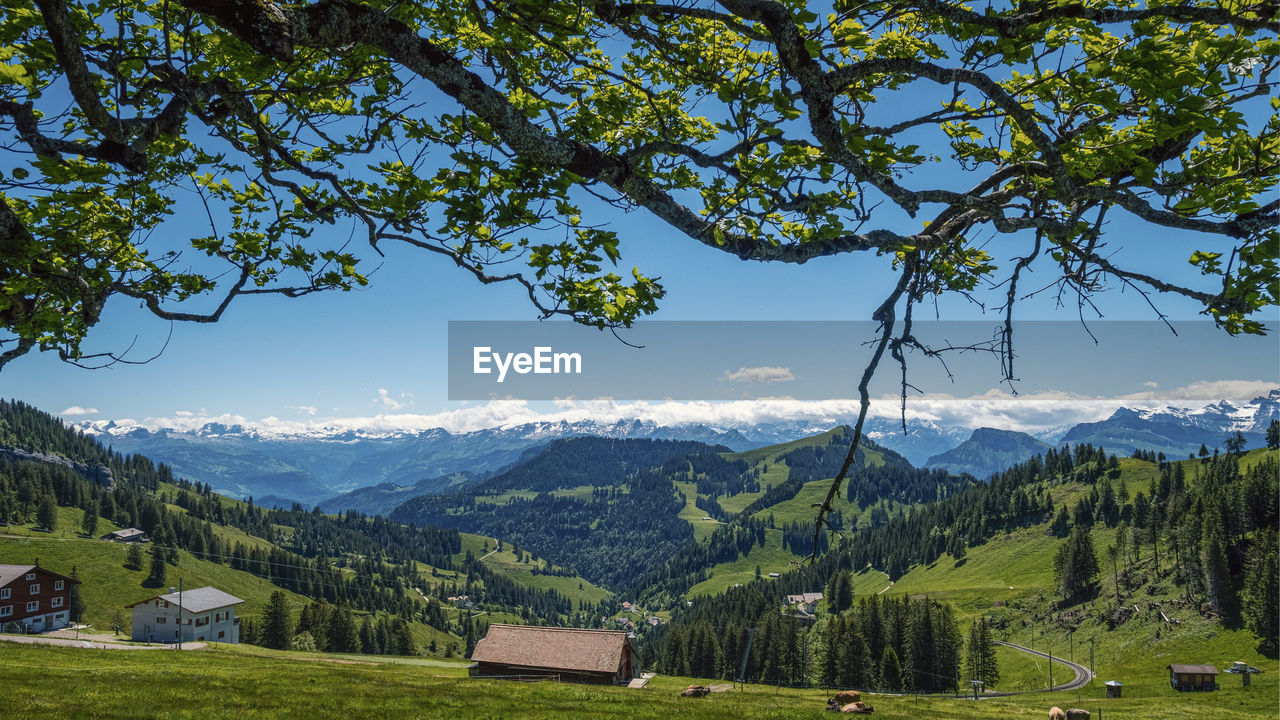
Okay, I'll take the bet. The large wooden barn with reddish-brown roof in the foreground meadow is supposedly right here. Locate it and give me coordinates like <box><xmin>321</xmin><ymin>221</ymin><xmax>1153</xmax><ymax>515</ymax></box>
<box><xmin>470</xmin><ymin>624</ymin><xmax>637</xmax><ymax>685</ymax></box>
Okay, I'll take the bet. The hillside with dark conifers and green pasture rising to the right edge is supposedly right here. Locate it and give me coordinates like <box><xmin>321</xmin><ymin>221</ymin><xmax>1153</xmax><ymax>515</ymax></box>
<box><xmin>644</xmin><ymin>445</ymin><xmax>1280</xmax><ymax>691</ymax></box>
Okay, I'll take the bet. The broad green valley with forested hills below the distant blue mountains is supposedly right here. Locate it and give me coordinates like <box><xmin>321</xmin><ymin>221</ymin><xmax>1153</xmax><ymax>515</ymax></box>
<box><xmin>0</xmin><ymin>394</ymin><xmax>1280</xmax><ymax>717</ymax></box>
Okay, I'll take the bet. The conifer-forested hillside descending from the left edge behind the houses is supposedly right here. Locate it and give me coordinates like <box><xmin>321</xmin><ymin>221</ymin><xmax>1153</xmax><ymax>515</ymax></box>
<box><xmin>0</xmin><ymin>402</ymin><xmax>606</xmax><ymax>653</ymax></box>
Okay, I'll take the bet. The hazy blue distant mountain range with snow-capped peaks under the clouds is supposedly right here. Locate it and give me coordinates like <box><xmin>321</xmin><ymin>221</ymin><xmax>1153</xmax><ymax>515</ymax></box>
<box><xmin>77</xmin><ymin>389</ymin><xmax>1280</xmax><ymax>502</ymax></box>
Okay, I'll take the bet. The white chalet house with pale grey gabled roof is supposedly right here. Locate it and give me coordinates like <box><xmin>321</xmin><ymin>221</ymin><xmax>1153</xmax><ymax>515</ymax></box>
<box><xmin>125</xmin><ymin>587</ymin><xmax>244</xmax><ymax>643</ymax></box>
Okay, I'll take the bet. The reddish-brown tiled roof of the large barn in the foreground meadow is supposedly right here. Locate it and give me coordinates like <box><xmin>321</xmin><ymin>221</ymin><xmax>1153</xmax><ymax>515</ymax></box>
<box><xmin>471</xmin><ymin>624</ymin><xmax>627</xmax><ymax>674</ymax></box>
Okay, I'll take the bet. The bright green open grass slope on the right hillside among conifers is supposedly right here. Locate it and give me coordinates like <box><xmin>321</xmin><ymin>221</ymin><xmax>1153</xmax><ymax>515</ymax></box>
<box><xmin>854</xmin><ymin>451</ymin><xmax>1280</xmax><ymax>702</ymax></box>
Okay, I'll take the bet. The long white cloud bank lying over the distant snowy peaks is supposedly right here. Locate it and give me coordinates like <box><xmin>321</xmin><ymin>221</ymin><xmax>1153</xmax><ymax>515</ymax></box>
<box><xmin>80</xmin><ymin>380</ymin><xmax>1276</xmax><ymax>437</ymax></box>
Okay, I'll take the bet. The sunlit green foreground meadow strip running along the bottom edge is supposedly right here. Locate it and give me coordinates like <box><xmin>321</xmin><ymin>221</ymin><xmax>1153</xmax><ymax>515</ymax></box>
<box><xmin>0</xmin><ymin>635</ymin><xmax>1277</xmax><ymax>720</ymax></box>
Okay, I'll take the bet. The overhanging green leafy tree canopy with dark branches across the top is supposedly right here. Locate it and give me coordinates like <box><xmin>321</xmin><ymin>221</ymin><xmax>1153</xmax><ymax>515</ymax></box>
<box><xmin>0</xmin><ymin>0</ymin><xmax>1280</xmax><ymax>363</ymax></box>
